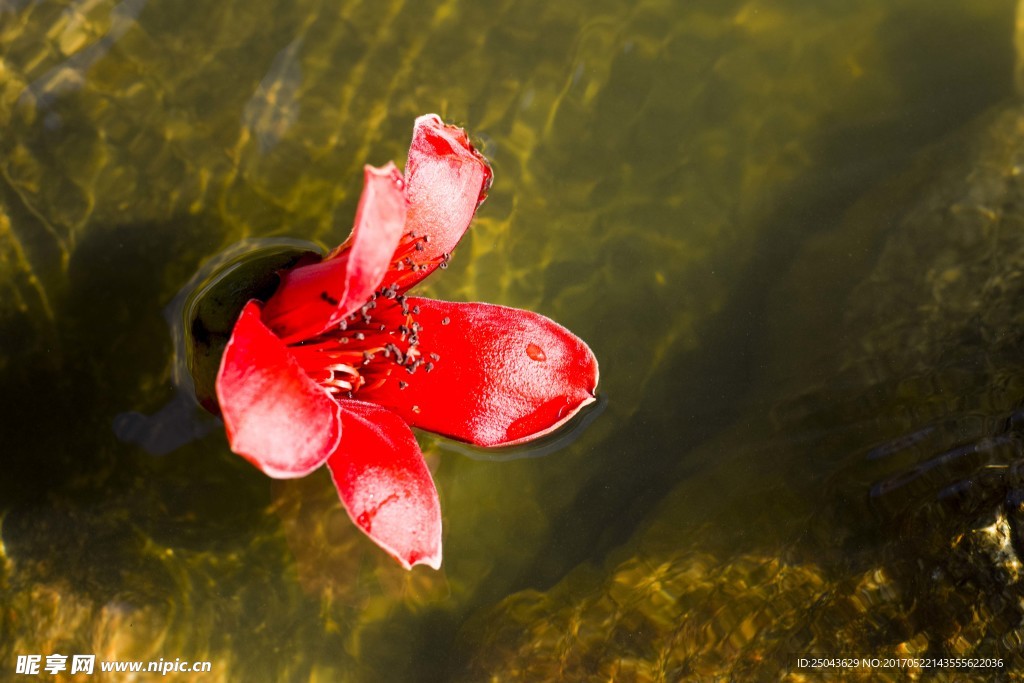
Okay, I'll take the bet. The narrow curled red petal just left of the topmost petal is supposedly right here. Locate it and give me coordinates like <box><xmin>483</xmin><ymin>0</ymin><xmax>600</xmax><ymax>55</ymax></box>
<box><xmin>263</xmin><ymin>163</ymin><xmax>406</xmax><ymax>343</ymax></box>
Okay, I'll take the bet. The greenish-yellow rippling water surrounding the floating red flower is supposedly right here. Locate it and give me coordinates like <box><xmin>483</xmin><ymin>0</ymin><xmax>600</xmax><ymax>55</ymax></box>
<box><xmin>0</xmin><ymin>0</ymin><xmax>1024</xmax><ymax>681</ymax></box>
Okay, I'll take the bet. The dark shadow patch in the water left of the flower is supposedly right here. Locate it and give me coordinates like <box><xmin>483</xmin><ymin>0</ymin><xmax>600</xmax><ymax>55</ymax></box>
<box><xmin>0</xmin><ymin>216</ymin><xmax>284</xmax><ymax>600</ymax></box>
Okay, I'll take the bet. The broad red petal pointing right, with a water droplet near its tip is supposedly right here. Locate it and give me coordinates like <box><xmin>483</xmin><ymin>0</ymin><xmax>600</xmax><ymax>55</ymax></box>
<box><xmin>359</xmin><ymin>297</ymin><xmax>598</xmax><ymax>446</ymax></box>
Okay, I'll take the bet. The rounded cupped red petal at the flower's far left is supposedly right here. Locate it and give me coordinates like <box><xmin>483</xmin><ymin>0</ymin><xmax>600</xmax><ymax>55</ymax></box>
<box><xmin>217</xmin><ymin>301</ymin><xmax>341</xmax><ymax>479</ymax></box>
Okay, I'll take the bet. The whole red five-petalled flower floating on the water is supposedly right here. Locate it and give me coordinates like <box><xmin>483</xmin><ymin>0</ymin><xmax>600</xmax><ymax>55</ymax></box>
<box><xmin>217</xmin><ymin>116</ymin><xmax>598</xmax><ymax>568</ymax></box>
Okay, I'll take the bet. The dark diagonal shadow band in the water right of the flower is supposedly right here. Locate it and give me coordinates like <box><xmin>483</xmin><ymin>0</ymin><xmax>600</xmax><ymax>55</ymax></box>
<box><xmin>495</xmin><ymin>0</ymin><xmax>1013</xmax><ymax>590</ymax></box>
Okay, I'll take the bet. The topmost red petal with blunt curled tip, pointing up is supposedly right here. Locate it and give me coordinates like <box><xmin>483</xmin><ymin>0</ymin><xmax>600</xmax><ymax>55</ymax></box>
<box><xmin>382</xmin><ymin>114</ymin><xmax>492</xmax><ymax>291</ymax></box>
